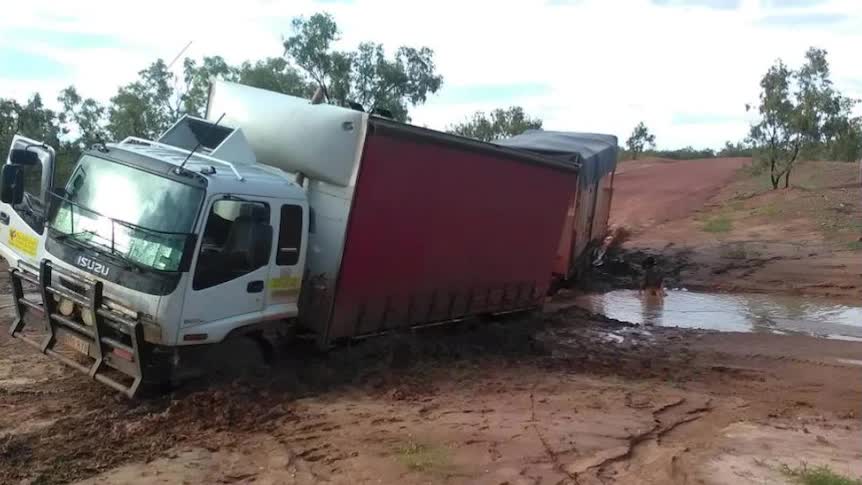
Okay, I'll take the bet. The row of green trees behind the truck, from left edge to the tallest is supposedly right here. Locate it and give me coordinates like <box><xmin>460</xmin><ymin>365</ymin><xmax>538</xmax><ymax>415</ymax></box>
<box><xmin>5</xmin><ymin>9</ymin><xmax>442</xmax><ymax>180</ymax></box>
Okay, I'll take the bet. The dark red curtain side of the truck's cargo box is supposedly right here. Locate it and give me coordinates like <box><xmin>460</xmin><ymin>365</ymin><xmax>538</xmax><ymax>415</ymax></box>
<box><xmin>328</xmin><ymin>124</ymin><xmax>577</xmax><ymax>339</ymax></box>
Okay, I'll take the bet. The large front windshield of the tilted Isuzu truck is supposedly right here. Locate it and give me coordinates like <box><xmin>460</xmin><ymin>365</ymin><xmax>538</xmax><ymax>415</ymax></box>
<box><xmin>50</xmin><ymin>155</ymin><xmax>204</xmax><ymax>271</ymax></box>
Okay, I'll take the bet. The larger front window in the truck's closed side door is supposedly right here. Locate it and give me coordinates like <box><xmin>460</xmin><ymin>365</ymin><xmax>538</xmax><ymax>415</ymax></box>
<box><xmin>192</xmin><ymin>199</ymin><xmax>272</xmax><ymax>290</ymax></box>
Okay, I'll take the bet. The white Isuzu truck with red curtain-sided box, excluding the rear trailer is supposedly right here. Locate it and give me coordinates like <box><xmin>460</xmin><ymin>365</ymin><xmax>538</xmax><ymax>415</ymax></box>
<box><xmin>0</xmin><ymin>82</ymin><xmax>577</xmax><ymax>396</ymax></box>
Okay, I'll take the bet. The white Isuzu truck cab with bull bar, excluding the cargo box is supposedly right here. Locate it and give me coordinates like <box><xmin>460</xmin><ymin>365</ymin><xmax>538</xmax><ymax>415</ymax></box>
<box><xmin>0</xmin><ymin>118</ymin><xmax>308</xmax><ymax>394</ymax></box>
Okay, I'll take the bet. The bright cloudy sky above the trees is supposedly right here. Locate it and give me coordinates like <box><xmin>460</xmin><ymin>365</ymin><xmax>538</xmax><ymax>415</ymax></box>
<box><xmin>0</xmin><ymin>0</ymin><xmax>862</xmax><ymax>148</ymax></box>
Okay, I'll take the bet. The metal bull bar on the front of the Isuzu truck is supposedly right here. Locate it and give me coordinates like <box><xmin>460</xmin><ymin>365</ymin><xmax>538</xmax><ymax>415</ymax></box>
<box><xmin>9</xmin><ymin>260</ymin><xmax>149</xmax><ymax>398</ymax></box>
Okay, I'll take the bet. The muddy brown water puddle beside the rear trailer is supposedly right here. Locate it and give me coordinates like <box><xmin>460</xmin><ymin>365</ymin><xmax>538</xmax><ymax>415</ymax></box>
<box><xmin>575</xmin><ymin>290</ymin><xmax>862</xmax><ymax>340</ymax></box>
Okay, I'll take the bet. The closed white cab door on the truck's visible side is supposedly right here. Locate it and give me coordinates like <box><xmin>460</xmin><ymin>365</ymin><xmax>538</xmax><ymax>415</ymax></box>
<box><xmin>178</xmin><ymin>196</ymin><xmax>278</xmax><ymax>344</ymax></box>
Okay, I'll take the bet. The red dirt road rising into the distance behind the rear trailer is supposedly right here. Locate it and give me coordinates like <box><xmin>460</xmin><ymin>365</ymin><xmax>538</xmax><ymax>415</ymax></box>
<box><xmin>610</xmin><ymin>158</ymin><xmax>751</xmax><ymax>231</ymax></box>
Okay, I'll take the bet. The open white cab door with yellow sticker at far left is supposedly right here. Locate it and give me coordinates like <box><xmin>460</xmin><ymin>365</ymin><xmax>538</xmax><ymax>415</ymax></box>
<box><xmin>0</xmin><ymin>135</ymin><xmax>54</xmax><ymax>267</ymax></box>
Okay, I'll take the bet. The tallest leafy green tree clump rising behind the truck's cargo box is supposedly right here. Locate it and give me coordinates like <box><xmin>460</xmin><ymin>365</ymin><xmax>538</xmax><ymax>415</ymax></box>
<box><xmin>284</xmin><ymin>13</ymin><xmax>443</xmax><ymax>121</ymax></box>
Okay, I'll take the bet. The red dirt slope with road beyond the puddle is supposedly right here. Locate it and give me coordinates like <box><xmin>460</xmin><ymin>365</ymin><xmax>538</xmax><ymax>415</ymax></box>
<box><xmin>610</xmin><ymin>158</ymin><xmax>862</xmax><ymax>298</ymax></box>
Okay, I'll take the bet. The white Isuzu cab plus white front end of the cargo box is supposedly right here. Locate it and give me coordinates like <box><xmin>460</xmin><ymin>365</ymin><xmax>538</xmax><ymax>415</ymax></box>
<box><xmin>0</xmin><ymin>83</ymin><xmax>368</xmax><ymax>396</ymax></box>
